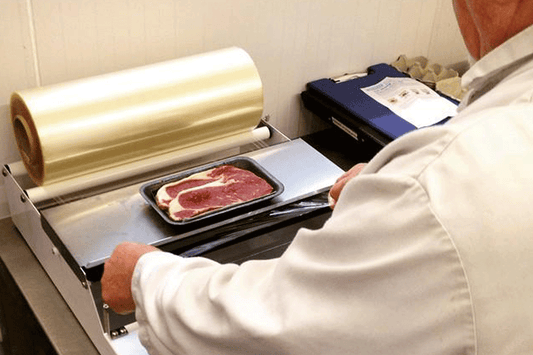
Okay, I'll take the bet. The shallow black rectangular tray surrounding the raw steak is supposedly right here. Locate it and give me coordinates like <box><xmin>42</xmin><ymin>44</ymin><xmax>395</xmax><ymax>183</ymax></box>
<box><xmin>140</xmin><ymin>157</ymin><xmax>284</xmax><ymax>226</ymax></box>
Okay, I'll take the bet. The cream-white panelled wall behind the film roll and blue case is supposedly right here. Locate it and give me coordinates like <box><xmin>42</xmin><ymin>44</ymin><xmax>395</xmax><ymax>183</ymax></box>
<box><xmin>0</xmin><ymin>0</ymin><xmax>465</xmax><ymax>217</ymax></box>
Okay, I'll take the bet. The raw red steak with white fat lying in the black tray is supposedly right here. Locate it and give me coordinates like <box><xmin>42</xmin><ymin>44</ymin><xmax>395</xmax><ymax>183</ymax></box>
<box><xmin>156</xmin><ymin>165</ymin><xmax>273</xmax><ymax>221</ymax></box>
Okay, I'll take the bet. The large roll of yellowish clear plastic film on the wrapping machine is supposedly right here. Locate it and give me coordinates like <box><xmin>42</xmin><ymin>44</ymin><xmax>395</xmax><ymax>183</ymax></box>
<box><xmin>11</xmin><ymin>48</ymin><xmax>263</xmax><ymax>185</ymax></box>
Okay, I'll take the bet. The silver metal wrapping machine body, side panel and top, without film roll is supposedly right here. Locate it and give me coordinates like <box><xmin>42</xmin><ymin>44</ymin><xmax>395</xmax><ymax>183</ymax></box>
<box><xmin>3</xmin><ymin>128</ymin><xmax>343</xmax><ymax>355</ymax></box>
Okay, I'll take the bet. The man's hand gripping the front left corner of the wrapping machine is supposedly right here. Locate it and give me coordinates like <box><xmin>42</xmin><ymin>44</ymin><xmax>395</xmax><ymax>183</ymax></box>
<box><xmin>101</xmin><ymin>242</ymin><xmax>159</xmax><ymax>314</ymax></box>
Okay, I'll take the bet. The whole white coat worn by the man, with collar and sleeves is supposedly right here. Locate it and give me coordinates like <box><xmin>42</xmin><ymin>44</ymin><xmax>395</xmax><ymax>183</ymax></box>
<box><xmin>132</xmin><ymin>27</ymin><xmax>533</xmax><ymax>355</ymax></box>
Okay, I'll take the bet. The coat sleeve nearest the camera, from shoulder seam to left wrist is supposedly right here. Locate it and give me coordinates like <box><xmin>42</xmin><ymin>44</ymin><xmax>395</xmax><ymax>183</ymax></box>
<box><xmin>132</xmin><ymin>174</ymin><xmax>475</xmax><ymax>355</ymax></box>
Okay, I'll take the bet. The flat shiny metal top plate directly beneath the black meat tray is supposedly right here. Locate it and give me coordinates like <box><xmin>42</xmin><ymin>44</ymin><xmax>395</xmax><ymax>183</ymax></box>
<box><xmin>41</xmin><ymin>140</ymin><xmax>342</xmax><ymax>268</ymax></box>
